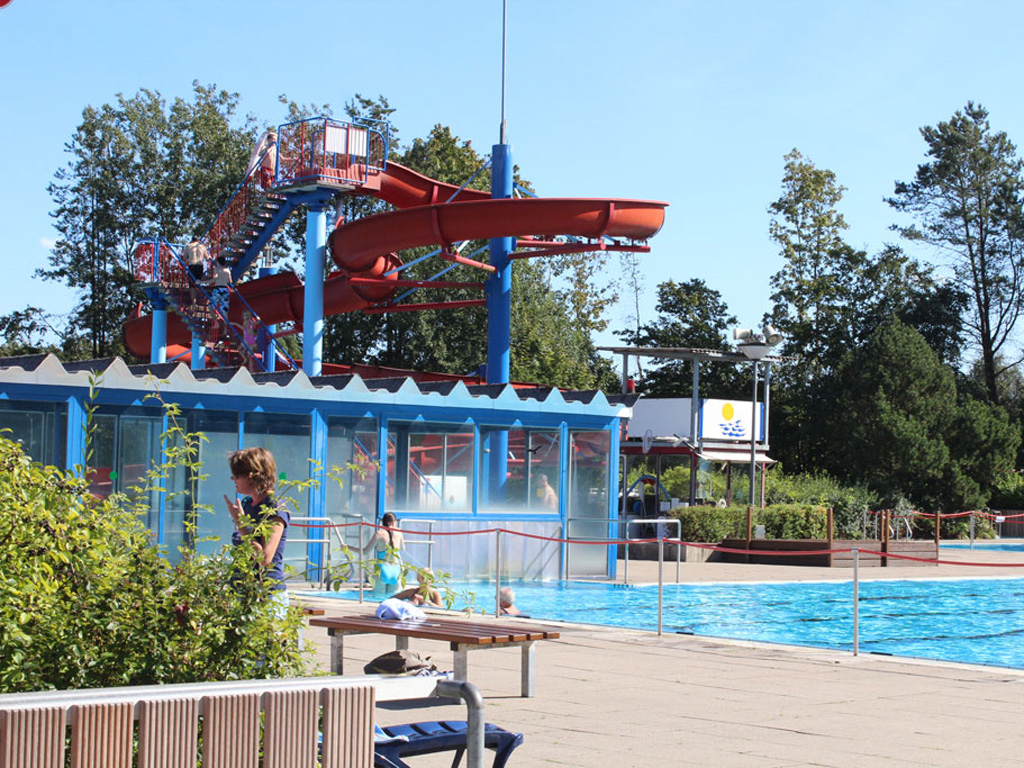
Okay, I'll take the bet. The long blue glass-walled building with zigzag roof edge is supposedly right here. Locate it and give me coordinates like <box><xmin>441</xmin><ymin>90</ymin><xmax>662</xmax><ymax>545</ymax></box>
<box><xmin>0</xmin><ymin>355</ymin><xmax>635</xmax><ymax>579</ymax></box>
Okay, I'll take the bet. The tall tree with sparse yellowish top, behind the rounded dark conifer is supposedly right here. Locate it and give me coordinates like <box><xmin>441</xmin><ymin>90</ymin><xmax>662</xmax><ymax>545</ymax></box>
<box><xmin>769</xmin><ymin>150</ymin><xmax>966</xmax><ymax>471</ymax></box>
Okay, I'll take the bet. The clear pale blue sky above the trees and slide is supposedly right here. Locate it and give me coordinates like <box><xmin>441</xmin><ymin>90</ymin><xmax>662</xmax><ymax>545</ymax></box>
<box><xmin>0</xmin><ymin>0</ymin><xmax>1024</xmax><ymax>358</ymax></box>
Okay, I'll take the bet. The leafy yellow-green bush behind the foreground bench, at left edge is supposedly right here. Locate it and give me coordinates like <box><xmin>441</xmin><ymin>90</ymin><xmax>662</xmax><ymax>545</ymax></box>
<box><xmin>0</xmin><ymin>437</ymin><xmax>306</xmax><ymax>692</ymax></box>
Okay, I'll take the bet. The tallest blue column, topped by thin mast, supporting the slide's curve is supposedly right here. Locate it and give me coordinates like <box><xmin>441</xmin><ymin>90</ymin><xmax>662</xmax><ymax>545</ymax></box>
<box><xmin>485</xmin><ymin>141</ymin><xmax>514</xmax><ymax>503</ymax></box>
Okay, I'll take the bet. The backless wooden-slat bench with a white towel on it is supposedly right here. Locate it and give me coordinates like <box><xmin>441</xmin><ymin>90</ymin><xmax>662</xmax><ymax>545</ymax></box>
<box><xmin>309</xmin><ymin>615</ymin><xmax>559</xmax><ymax>698</ymax></box>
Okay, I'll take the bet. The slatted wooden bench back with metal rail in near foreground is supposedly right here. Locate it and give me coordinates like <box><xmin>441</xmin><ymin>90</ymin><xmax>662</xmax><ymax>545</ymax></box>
<box><xmin>0</xmin><ymin>676</ymin><xmax>466</xmax><ymax>768</ymax></box>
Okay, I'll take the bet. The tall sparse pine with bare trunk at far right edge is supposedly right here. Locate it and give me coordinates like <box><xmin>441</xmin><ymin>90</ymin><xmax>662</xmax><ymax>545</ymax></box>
<box><xmin>888</xmin><ymin>101</ymin><xmax>1024</xmax><ymax>402</ymax></box>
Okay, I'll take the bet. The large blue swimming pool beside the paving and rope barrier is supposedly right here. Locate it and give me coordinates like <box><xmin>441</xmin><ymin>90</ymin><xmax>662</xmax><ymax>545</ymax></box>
<box><xmin>314</xmin><ymin>579</ymin><xmax>1024</xmax><ymax>669</ymax></box>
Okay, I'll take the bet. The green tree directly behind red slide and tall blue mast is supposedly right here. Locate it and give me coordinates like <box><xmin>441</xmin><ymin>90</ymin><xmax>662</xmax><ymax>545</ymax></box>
<box><xmin>325</xmin><ymin>108</ymin><xmax>610</xmax><ymax>387</ymax></box>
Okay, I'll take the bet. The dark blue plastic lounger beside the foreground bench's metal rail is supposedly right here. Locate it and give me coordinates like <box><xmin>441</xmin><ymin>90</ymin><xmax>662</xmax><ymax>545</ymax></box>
<box><xmin>374</xmin><ymin>720</ymin><xmax>522</xmax><ymax>768</ymax></box>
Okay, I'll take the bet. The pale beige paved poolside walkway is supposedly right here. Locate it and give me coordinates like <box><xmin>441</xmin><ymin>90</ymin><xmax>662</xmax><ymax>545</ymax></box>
<box><xmin>296</xmin><ymin>550</ymin><xmax>1024</xmax><ymax>768</ymax></box>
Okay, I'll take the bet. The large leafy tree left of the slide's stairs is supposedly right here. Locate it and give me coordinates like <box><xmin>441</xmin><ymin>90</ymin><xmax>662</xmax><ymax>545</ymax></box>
<box><xmin>37</xmin><ymin>83</ymin><xmax>253</xmax><ymax>356</ymax></box>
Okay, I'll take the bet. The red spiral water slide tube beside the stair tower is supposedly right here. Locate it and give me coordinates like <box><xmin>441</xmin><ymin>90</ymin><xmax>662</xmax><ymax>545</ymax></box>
<box><xmin>125</xmin><ymin>163</ymin><xmax>668</xmax><ymax>357</ymax></box>
